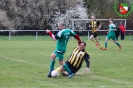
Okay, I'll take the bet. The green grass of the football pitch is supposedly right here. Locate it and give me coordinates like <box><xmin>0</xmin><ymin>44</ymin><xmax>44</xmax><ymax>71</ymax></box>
<box><xmin>0</xmin><ymin>36</ymin><xmax>133</xmax><ymax>88</ymax></box>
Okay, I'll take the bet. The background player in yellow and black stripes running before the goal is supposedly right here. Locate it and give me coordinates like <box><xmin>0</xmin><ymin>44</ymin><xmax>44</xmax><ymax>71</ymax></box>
<box><xmin>89</xmin><ymin>14</ymin><xmax>102</xmax><ymax>48</ymax></box>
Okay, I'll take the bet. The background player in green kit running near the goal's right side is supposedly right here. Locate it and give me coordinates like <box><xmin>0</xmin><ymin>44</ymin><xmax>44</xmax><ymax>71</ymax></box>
<box><xmin>102</xmin><ymin>18</ymin><xmax>121</xmax><ymax>50</ymax></box>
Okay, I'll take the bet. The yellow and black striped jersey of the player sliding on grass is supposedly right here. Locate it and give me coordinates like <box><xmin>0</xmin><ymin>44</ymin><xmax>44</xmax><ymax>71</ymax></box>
<box><xmin>68</xmin><ymin>47</ymin><xmax>90</xmax><ymax>68</ymax></box>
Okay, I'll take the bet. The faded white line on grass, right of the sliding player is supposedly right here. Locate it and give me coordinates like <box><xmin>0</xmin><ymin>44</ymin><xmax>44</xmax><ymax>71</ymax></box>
<box><xmin>77</xmin><ymin>69</ymin><xmax>133</xmax><ymax>87</ymax></box>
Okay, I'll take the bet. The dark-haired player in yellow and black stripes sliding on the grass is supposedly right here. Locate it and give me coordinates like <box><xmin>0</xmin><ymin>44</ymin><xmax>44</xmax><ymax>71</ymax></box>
<box><xmin>56</xmin><ymin>42</ymin><xmax>90</xmax><ymax>76</ymax></box>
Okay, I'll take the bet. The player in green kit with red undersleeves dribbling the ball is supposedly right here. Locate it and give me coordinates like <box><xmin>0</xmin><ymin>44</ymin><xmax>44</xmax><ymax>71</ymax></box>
<box><xmin>46</xmin><ymin>22</ymin><xmax>81</xmax><ymax>78</ymax></box>
